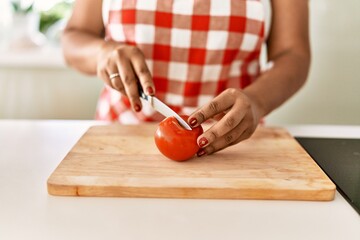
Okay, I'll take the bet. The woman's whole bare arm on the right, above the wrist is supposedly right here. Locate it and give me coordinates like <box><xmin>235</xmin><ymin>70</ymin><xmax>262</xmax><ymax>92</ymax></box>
<box><xmin>244</xmin><ymin>0</ymin><xmax>311</xmax><ymax>117</ymax></box>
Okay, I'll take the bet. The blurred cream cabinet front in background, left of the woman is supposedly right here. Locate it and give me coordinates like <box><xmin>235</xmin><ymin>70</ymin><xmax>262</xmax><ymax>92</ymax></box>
<box><xmin>0</xmin><ymin>67</ymin><xmax>102</xmax><ymax>119</ymax></box>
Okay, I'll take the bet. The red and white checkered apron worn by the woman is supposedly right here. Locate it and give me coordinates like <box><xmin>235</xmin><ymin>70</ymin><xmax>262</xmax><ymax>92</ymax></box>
<box><xmin>96</xmin><ymin>0</ymin><xmax>264</xmax><ymax>124</ymax></box>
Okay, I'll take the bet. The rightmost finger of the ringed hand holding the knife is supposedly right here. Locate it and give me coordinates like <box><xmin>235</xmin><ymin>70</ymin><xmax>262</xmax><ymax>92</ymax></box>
<box><xmin>131</xmin><ymin>48</ymin><xmax>155</xmax><ymax>95</ymax></box>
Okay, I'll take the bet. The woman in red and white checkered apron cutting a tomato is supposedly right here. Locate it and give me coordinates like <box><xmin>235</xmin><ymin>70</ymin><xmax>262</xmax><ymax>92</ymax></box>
<box><xmin>62</xmin><ymin>0</ymin><xmax>310</xmax><ymax>156</ymax></box>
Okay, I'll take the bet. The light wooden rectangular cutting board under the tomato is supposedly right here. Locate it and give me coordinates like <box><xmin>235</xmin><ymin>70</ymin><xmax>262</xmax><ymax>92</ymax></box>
<box><xmin>47</xmin><ymin>124</ymin><xmax>335</xmax><ymax>201</ymax></box>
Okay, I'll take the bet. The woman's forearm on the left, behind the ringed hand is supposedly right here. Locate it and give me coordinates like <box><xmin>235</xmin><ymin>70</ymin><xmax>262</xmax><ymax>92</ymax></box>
<box><xmin>62</xmin><ymin>28</ymin><xmax>105</xmax><ymax>75</ymax></box>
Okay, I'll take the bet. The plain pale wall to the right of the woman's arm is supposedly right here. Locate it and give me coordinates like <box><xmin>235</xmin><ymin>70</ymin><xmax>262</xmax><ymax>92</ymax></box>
<box><xmin>267</xmin><ymin>0</ymin><xmax>360</xmax><ymax>125</ymax></box>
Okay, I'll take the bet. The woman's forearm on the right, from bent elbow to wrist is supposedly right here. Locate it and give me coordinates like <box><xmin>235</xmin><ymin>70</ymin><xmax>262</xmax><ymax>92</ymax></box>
<box><xmin>244</xmin><ymin>50</ymin><xmax>310</xmax><ymax>117</ymax></box>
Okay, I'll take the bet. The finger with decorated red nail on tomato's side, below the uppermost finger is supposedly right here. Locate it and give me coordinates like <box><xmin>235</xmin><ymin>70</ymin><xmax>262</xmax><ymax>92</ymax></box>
<box><xmin>198</xmin><ymin>103</ymin><xmax>246</xmax><ymax>148</ymax></box>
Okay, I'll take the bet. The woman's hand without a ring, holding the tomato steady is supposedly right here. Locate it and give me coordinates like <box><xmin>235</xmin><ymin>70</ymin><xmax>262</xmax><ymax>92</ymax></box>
<box><xmin>188</xmin><ymin>88</ymin><xmax>262</xmax><ymax>156</ymax></box>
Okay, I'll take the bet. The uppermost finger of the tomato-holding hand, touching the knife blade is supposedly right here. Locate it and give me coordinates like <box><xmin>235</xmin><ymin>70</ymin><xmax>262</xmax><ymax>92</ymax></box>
<box><xmin>188</xmin><ymin>89</ymin><xmax>239</xmax><ymax>127</ymax></box>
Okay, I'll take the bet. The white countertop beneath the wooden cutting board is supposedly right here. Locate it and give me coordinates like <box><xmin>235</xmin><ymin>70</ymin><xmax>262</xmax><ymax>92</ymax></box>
<box><xmin>0</xmin><ymin>120</ymin><xmax>360</xmax><ymax>240</ymax></box>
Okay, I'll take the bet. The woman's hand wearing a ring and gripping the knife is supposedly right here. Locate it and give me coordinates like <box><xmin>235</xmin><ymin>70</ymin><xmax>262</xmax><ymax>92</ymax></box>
<box><xmin>97</xmin><ymin>41</ymin><xmax>155</xmax><ymax>112</ymax></box>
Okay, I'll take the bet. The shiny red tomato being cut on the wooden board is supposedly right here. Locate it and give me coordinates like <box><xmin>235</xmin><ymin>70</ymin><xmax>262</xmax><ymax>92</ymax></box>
<box><xmin>155</xmin><ymin>116</ymin><xmax>203</xmax><ymax>161</ymax></box>
